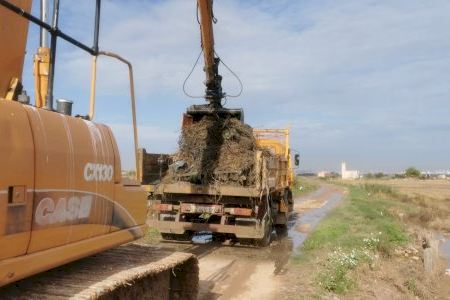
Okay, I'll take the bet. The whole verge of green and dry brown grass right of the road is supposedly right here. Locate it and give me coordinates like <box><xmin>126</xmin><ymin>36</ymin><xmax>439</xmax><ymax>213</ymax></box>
<box><xmin>286</xmin><ymin>180</ymin><xmax>450</xmax><ymax>299</ymax></box>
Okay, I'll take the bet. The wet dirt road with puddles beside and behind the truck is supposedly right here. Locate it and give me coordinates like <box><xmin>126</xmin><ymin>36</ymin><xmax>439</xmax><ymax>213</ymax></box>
<box><xmin>154</xmin><ymin>185</ymin><xmax>345</xmax><ymax>299</ymax></box>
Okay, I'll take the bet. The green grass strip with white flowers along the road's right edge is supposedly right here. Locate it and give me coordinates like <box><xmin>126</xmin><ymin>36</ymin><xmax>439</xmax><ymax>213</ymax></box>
<box><xmin>293</xmin><ymin>185</ymin><xmax>408</xmax><ymax>294</ymax></box>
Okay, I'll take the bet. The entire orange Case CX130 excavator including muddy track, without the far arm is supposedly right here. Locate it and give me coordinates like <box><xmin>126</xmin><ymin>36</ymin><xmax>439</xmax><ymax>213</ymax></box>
<box><xmin>0</xmin><ymin>0</ymin><xmax>198</xmax><ymax>299</ymax></box>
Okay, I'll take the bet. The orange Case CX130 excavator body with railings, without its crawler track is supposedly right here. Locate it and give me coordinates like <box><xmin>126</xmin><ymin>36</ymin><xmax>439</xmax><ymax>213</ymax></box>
<box><xmin>0</xmin><ymin>0</ymin><xmax>147</xmax><ymax>286</ymax></box>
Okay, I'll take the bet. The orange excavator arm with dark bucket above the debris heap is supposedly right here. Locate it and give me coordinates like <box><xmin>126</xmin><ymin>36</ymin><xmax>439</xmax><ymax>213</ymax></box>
<box><xmin>183</xmin><ymin>0</ymin><xmax>244</xmax><ymax>125</ymax></box>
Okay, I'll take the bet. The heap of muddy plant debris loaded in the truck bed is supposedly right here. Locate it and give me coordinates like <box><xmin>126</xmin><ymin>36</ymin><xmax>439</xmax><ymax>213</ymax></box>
<box><xmin>162</xmin><ymin>116</ymin><xmax>272</xmax><ymax>186</ymax></box>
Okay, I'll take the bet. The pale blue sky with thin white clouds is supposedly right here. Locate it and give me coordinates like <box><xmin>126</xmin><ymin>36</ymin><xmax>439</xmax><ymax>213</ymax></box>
<box><xmin>20</xmin><ymin>0</ymin><xmax>450</xmax><ymax>172</ymax></box>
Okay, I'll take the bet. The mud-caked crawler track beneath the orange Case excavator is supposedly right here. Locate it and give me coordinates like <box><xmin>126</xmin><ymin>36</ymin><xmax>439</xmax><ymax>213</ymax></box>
<box><xmin>0</xmin><ymin>244</ymin><xmax>199</xmax><ymax>299</ymax></box>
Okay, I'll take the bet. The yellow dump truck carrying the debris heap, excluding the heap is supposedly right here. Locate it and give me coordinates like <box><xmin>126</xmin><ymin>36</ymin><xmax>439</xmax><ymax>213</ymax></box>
<box><xmin>138</xmin><ymin>129</ymin><xmax>294</xmax><ymax>246</ymax></box>
